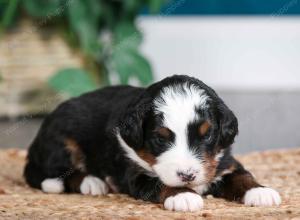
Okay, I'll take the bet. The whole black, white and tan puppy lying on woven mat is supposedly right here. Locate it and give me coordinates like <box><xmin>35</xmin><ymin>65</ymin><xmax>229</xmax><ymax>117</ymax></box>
<box><xmin>24</xmin><ymin>76</ymin><xmax>281</xmax><ymax>211</ymax></box>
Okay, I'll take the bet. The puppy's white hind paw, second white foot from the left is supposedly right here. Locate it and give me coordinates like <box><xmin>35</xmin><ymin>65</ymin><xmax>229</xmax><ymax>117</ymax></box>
<box><xmin>80</xmin><ymin>175</ymin><xmax>108</xmax><ymax>196</ymax></box>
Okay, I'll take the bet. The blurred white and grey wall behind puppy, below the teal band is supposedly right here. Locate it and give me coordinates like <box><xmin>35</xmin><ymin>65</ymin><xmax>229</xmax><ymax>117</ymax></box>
<box><xmin>139</xmin><ymin>16</ymin><xmax>300</xmax><ymax>153</ymax></box>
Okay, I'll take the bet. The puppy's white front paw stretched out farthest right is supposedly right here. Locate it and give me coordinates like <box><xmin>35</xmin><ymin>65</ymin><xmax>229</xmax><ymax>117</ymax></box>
<box><xmin>244</xmin><ymin>187</ymin><xmax>281</xmax><ymax>206</ymax></box>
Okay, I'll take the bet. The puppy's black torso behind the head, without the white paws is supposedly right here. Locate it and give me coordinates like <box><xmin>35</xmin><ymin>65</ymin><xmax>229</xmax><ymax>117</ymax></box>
<box><xmin>25</xmin><ymin>86</ymin><xmax>144</xmax><ymax>193</ymax></box>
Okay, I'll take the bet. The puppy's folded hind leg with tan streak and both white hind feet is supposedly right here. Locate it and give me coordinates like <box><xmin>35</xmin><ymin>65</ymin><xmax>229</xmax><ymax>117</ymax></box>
<box><xmin>24</xmin><ymin>139</ymin><xmax>108</xmax><ymax>195</ymax></box>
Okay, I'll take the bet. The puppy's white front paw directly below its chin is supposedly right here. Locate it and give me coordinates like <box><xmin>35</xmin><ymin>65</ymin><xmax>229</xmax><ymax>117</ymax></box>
<box><xmin>164</xmin><ymin>192</ymin><xmax>203</xmax><ymax>212</ymax></box>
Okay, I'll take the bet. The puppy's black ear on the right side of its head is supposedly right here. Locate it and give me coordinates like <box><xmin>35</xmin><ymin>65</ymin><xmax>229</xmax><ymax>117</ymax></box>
<box><xmin>218</xmin><ymin>102</ymin><xmax>238</xmax><ymax>148</ymax></box>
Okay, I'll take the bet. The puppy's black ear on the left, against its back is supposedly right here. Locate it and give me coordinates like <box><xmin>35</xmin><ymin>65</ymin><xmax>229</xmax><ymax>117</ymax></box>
<box><xmin>119</xmin><ymin>95</ymin><xmax>151</xmax><ymax>149</ymax></box>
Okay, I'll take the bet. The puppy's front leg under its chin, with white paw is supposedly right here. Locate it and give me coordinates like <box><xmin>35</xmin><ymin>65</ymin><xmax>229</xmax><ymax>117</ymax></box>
<box><xmin>129</xmin><ymin>175</ymin><xmax>203</xmax><ymax>211</ymax></box>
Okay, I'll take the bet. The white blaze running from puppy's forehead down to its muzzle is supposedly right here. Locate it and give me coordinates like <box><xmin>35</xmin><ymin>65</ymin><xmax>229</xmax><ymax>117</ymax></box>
<box><xmin>153</xmin><ymin>84</ymin><xmax>208</xmax><ymax>186</ymax></box>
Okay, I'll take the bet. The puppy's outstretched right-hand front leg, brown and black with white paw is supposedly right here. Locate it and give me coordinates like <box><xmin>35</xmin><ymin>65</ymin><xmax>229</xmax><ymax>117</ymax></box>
<box><xmin>210</xmin><ymin>158</ymin><xmax>281</xmax><ymax>206</ymax></box>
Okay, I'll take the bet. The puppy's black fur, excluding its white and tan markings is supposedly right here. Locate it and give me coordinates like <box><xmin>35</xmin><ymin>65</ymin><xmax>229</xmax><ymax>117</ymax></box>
<box><xmin>24</xmin><ymin>76</ymin><xmax>262</xmax><ymax>206</ymax></box>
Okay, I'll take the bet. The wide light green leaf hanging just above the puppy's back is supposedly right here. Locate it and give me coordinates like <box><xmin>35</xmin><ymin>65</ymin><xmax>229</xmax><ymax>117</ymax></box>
<box><xmin>48</xmin><ymin>68</ymin><xmax>97</xmax><ymax>97</ymax></box>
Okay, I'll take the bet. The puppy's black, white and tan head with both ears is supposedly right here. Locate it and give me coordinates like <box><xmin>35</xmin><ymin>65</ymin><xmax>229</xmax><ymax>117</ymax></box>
<box><xmin>118</xmin><ymin>76</ymin><xmax>238</xmax><ymax>187</ymax></box>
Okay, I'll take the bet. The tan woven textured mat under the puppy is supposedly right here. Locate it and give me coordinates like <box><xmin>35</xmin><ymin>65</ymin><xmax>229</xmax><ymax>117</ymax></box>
<box><xmin>0</xmin><ymin>148</ymin><xmax>300</xmax><ymax>220</ymax></box>
